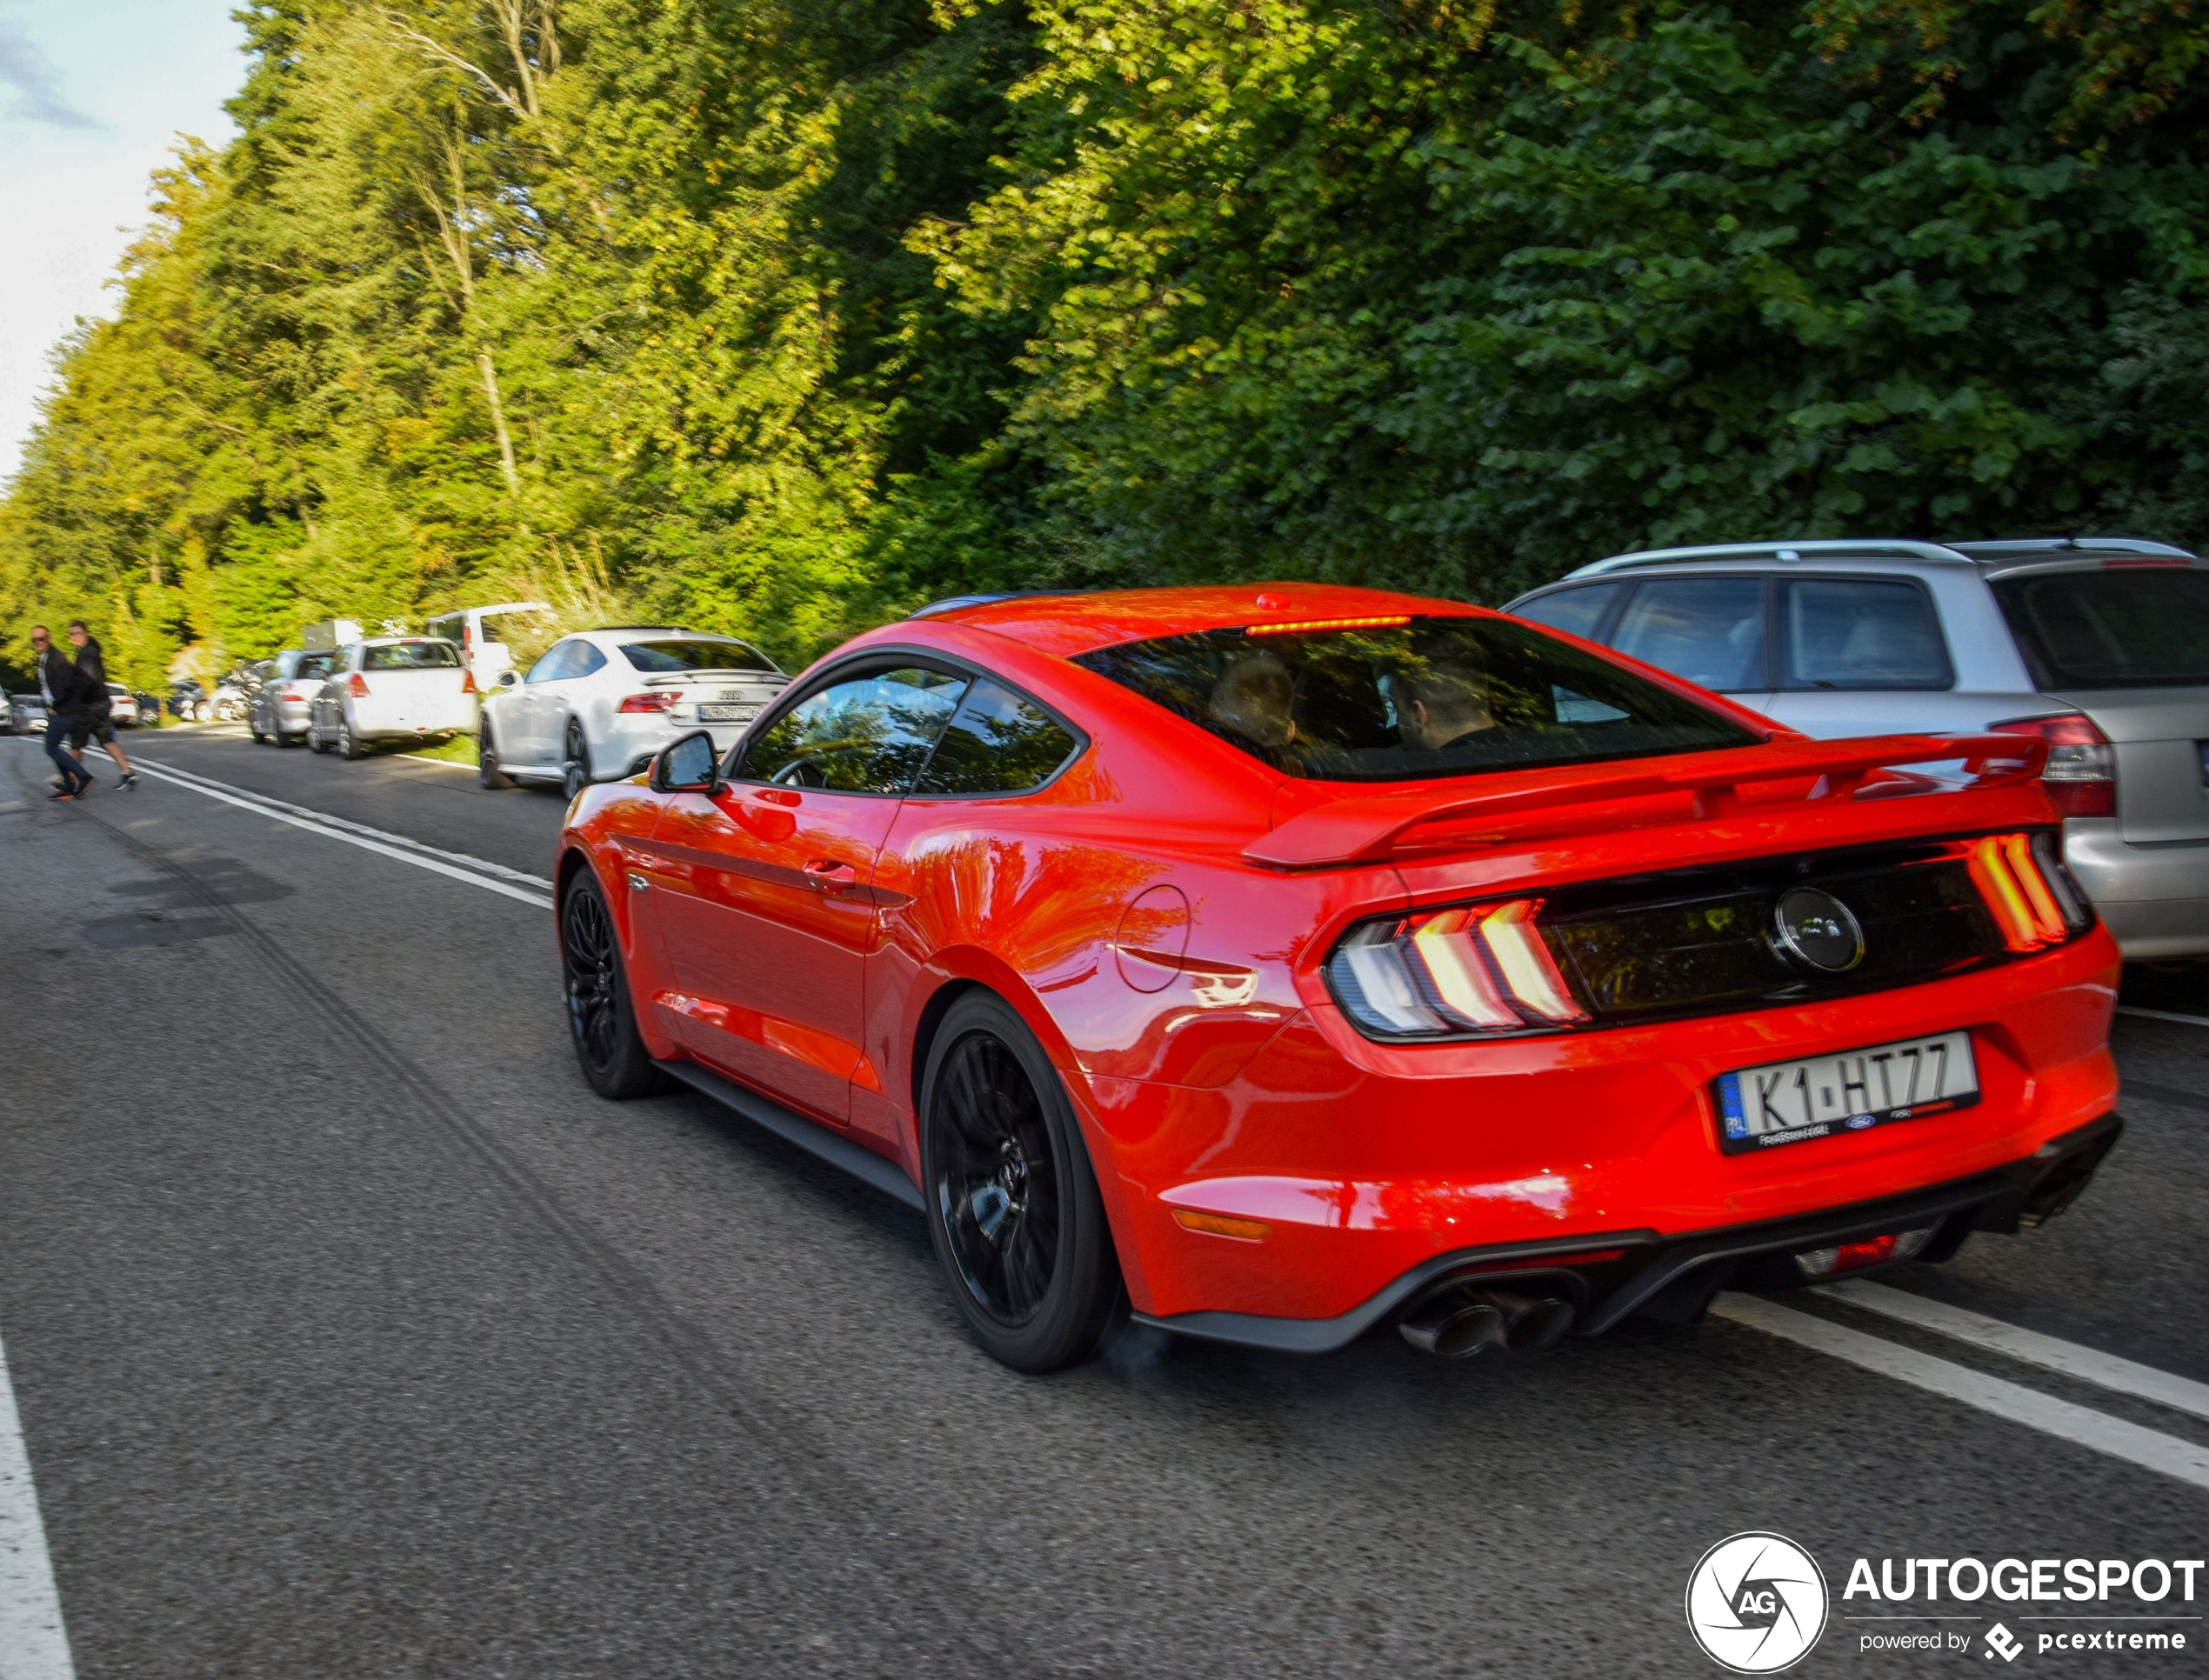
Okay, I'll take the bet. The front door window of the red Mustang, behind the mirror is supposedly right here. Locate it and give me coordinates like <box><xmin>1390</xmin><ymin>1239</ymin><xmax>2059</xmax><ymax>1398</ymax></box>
<box><xmin>736</xmin><ymin>664</ymin><xmax>968</xmax><ymax>792</ymax></box>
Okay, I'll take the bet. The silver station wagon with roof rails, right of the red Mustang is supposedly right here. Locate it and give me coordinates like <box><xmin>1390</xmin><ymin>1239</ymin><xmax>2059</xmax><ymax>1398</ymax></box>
<box><xmin>1505</xmin><ymin>537</ymin><xmax>2209</xmax><ymax>958</ymax></box>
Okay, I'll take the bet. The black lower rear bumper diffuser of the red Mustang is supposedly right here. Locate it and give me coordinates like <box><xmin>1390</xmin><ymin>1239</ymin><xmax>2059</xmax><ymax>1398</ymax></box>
<box><xmin>1133</xmin><ymin>1113</ymin><xmax>2123</xmax><ymax>1353</ymax></box>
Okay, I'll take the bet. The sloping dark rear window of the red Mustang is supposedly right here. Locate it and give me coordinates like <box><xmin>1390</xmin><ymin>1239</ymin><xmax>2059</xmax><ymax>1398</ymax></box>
<box><xmin>1076</xmin><ymin>618</ymin><xmax>1763</xmax><ymax>782</ymax></box>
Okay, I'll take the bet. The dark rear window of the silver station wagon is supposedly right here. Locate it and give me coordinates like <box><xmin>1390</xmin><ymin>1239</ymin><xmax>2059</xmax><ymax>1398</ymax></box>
<box><xmin>1995</xmin><ymin>567</ymin><xmax>2209</xmax><ymax>689</ymax></box>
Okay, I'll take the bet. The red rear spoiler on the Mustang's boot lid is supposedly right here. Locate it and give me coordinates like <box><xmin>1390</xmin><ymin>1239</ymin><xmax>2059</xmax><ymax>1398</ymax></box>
<box><xmin>1244</xmin><ymin>735</ymin><xmax>2048</xmax><ymax>870</ymax></box>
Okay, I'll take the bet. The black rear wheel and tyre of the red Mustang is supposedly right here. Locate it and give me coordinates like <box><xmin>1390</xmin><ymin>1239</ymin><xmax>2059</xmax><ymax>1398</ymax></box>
<box><xmin>921</xmin><ymin>991</ymin><xmax>1120</xmax><ymax>1373</ymax></box>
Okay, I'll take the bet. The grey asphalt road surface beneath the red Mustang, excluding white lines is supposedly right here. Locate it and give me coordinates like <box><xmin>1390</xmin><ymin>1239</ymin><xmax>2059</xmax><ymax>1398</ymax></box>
<box><xmin>0</xmin><ymin>730</ymin><xmax>2209</xmax><ymax>1680</ymax></box>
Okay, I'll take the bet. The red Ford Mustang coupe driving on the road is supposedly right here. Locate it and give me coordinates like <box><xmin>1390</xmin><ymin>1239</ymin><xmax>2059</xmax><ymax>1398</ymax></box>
<box><xmin>559</xmin><ymin>585</ymin><xmax>2119</xmax><ymax>1371</ymax></box>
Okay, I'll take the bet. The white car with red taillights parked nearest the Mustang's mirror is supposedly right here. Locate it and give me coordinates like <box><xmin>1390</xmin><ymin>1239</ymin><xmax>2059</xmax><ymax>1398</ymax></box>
<box><xmin>477</xmin><ymin>627</ymin><xmax>789</xmax><ymax>799</ymax></box>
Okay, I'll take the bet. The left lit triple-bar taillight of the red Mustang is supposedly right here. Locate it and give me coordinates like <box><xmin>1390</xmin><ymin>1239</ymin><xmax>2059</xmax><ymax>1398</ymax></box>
<box><xmin>1328</xmin><ymin>898</ymin><xmax>1588</xmax><ymax>1037</ymax></box>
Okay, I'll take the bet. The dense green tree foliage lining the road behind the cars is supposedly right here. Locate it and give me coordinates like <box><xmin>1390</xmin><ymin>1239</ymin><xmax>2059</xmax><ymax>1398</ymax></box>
<box><xmin>0</xmin><ymin>0</ymin><xmax>2209</xmax><ymax>680</ymax></box>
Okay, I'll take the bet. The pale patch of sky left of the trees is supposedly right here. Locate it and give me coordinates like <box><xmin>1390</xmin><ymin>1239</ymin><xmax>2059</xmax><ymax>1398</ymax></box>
<box><xmin>0</xmin><ymin>0</ymin><xmax>245</xmax><ymax>477</ymax></box>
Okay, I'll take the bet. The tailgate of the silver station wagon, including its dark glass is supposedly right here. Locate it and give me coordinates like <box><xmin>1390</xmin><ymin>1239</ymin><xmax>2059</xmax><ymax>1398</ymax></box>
<box><xmin>1991</xmin><ymin>558</ymin><xmax>2209</xmax><ymax>845</ymax></box>
